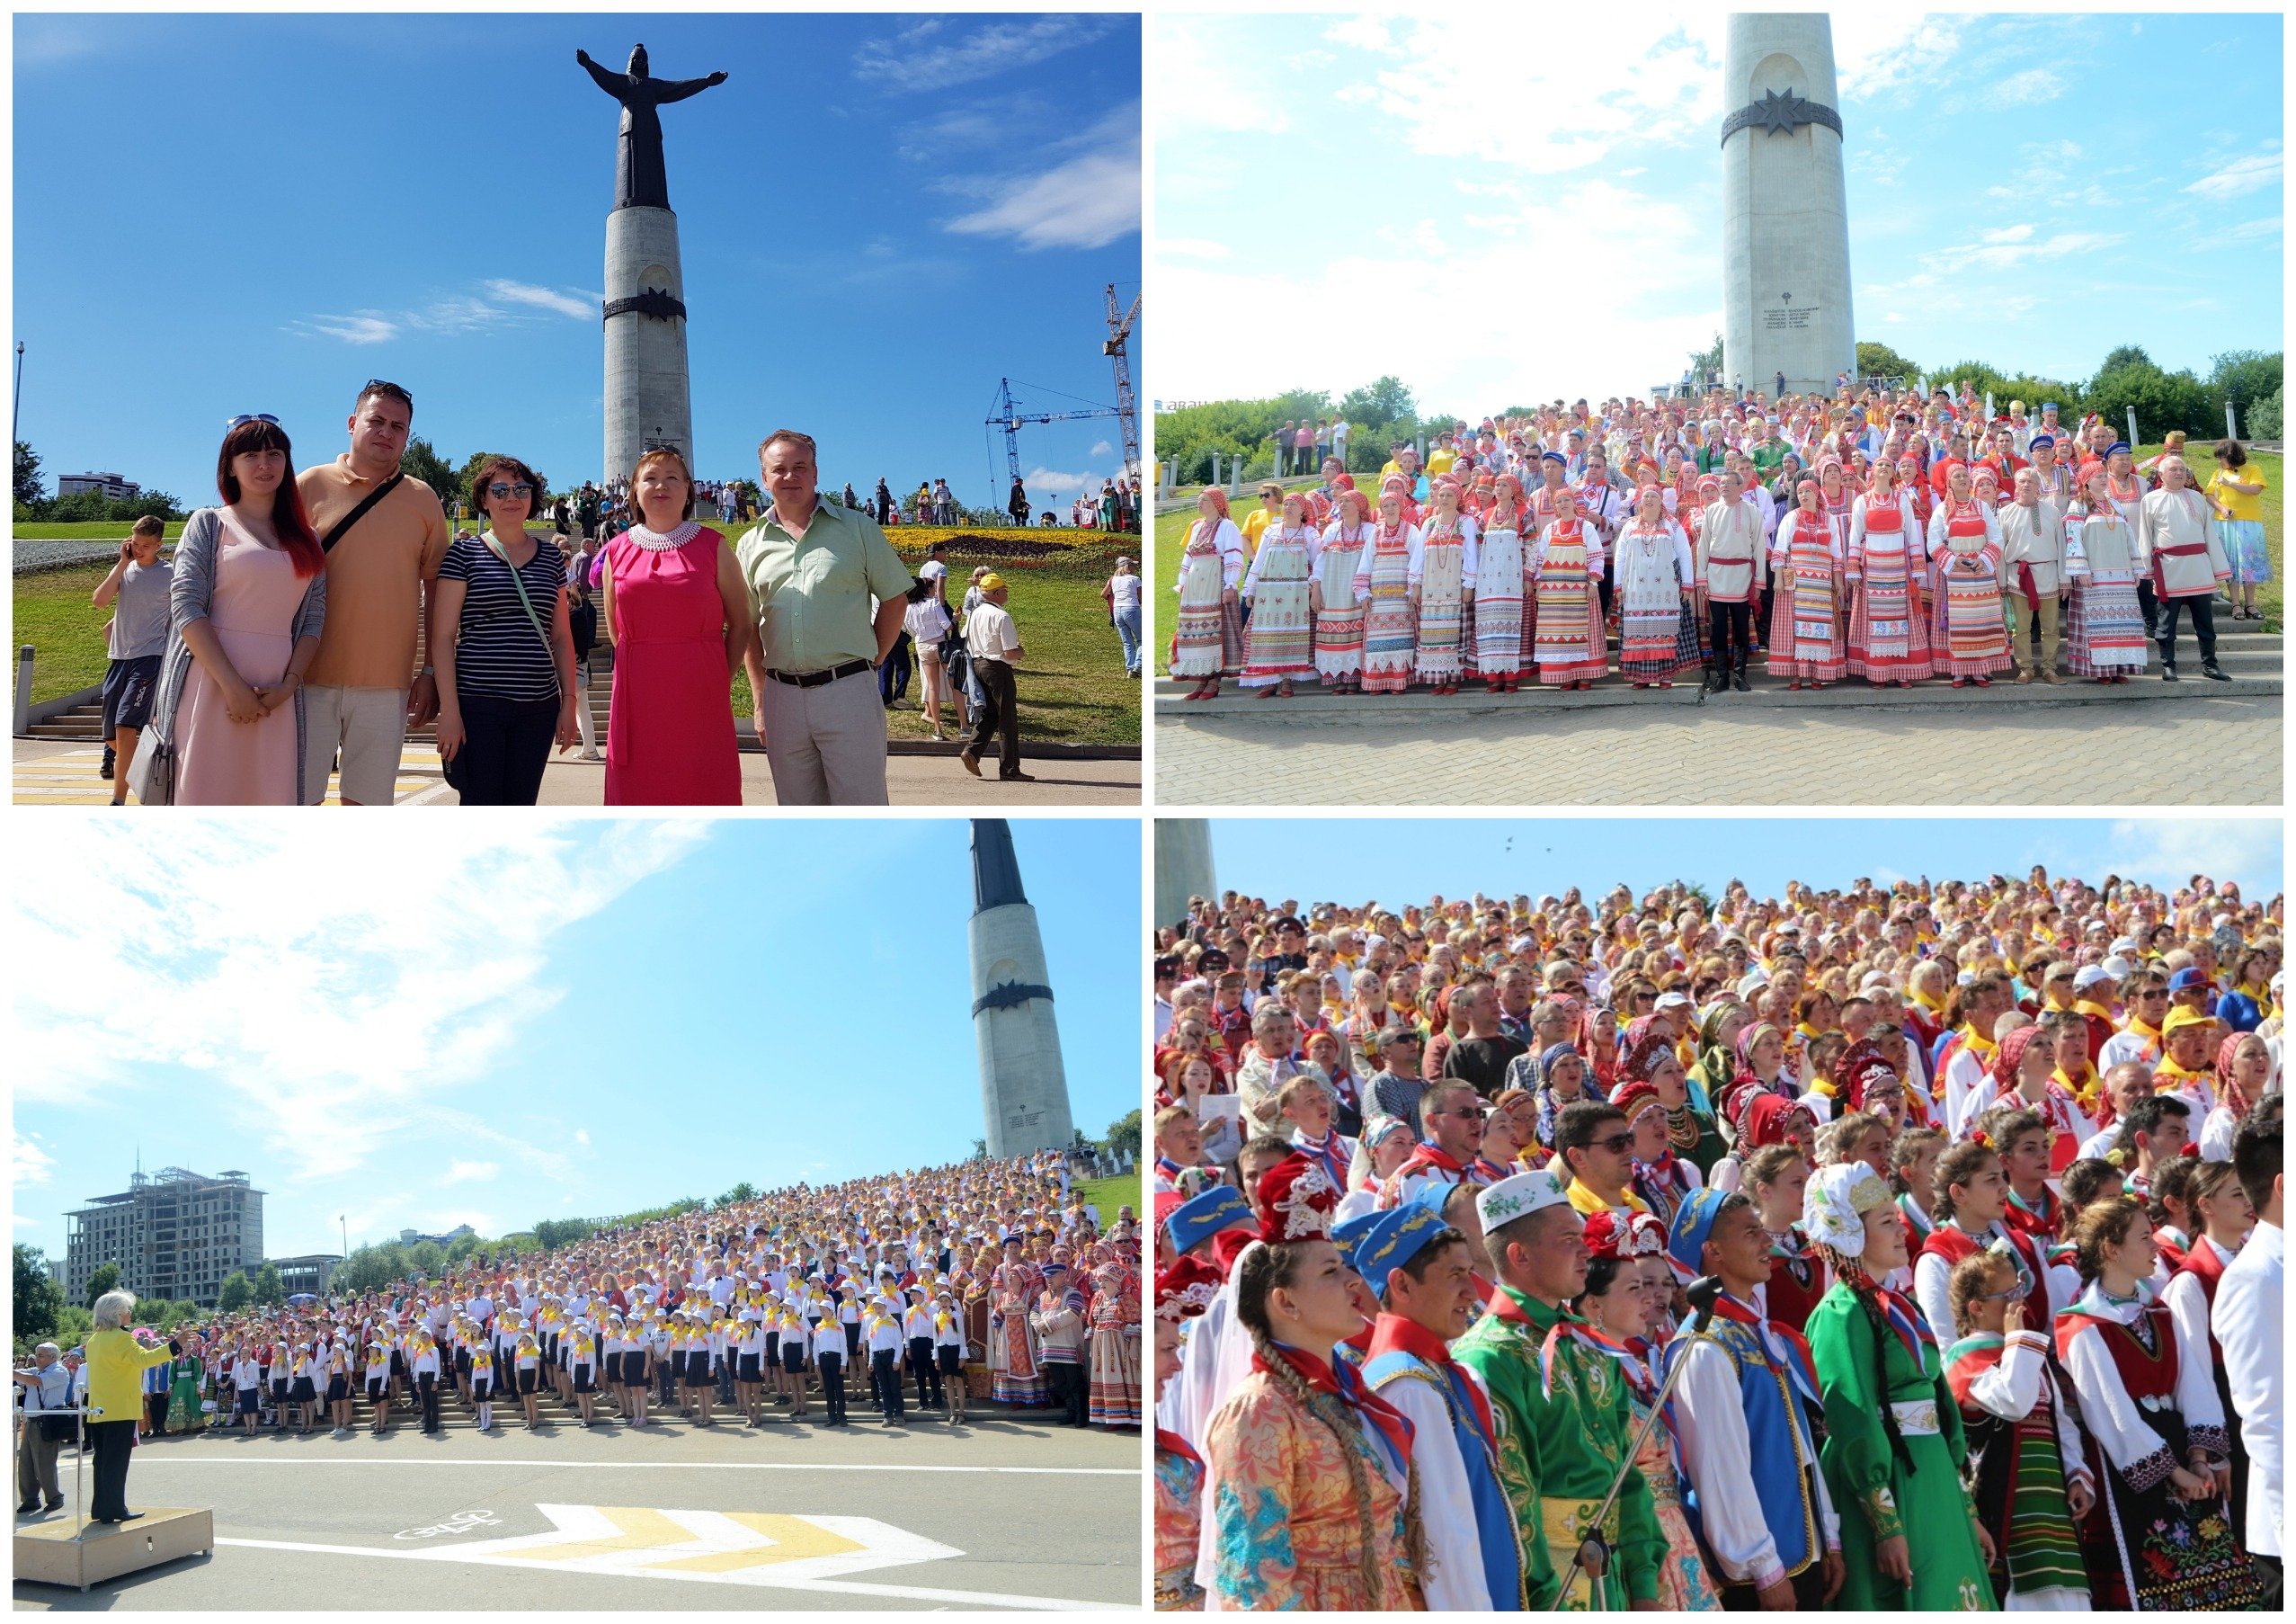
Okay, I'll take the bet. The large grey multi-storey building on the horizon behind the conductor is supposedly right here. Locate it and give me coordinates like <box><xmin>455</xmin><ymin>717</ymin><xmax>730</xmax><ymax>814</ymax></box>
<box><xmin>65</xmin><ymin>1167</ymin><xmax>264</xmax><ymax>1307</ymax></box>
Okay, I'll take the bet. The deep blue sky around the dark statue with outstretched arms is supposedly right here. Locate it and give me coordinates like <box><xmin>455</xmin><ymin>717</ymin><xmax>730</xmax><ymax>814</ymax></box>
<box><xmin>13</xmin><ymin>13</ymin><xmax>1141</xmax><ymax>505</ymax></box>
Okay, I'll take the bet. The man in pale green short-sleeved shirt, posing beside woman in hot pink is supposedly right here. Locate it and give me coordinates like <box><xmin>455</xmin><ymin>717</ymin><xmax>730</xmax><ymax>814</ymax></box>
<box><xmin>734</xmin><ymin>430</ymin><xmax>913</xmax><ymax>807</ymax></box>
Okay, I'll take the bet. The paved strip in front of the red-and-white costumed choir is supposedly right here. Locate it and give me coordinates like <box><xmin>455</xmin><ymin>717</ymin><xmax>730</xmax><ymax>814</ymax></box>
<box><xmin>1155</xmin><ymin>696</ymin><xmax>2280</xmax><ymax>811</ymax></box>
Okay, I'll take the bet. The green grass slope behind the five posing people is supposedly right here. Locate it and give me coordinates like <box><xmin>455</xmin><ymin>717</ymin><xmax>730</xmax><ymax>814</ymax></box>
<box><xmin>16</xmin><ymin>526</ymin><xmax>1141</xmax><ymax>745</ymax></box>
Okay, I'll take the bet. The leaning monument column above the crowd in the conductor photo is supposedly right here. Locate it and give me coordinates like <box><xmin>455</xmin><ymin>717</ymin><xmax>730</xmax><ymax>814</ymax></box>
<box><xmin>966</xmin><ymin>817</ymin><xmax>1074</xmax><ymax>1156</ymax></box>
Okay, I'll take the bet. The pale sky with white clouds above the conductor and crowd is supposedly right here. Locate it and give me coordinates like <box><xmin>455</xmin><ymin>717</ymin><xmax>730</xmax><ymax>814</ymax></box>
<box><xmin>9</xmin><ymin>817</ymin><xmax>1141</xmax><ymax>1256</ymax></box>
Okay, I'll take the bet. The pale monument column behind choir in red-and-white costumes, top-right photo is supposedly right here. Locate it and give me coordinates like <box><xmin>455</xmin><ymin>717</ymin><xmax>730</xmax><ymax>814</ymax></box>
<box><xmin>1722</xmin><ymin>12</ymin><xmax>1857</xmax><ymax>395</ymax></box>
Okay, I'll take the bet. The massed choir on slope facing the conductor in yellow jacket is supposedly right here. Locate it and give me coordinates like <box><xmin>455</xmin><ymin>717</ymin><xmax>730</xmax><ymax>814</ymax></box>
<box><xmin>65</xmin><ymin>1153</ymin><xmax>1141</xmax><ymax>1438</ymax></box>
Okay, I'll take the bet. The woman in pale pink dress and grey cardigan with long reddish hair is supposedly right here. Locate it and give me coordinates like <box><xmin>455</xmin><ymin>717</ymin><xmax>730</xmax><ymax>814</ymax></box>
<box><xmin>154</xmin><ymin>415</ymin><xmax>326</xmax><ymax>807</ymax></box>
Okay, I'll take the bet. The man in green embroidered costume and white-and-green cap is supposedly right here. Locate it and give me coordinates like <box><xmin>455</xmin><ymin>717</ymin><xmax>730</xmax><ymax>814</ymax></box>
<box><xmin>1451</xmin><ymin>1167</ymin><xmax>1667</xmax><ymax>1612</ymax></box>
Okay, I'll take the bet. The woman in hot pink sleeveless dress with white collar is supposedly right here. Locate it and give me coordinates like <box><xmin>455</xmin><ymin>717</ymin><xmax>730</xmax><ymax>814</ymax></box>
<box><xmin>600</xmin><ymin>448</ymin><xmax>753</xmax><ymax>807</ymax></box>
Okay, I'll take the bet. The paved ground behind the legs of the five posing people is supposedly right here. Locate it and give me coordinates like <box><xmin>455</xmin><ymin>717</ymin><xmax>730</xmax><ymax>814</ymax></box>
<box><xmin>16</xmin><ymin>740</ymin><xmax>1141</xmax><ymax>811</ymax></box>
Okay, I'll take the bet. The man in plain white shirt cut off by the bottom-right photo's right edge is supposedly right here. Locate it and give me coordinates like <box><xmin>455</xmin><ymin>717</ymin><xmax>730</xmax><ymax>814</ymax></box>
<box><xmin>2209</xmin><ymin>1116</ymin><xmax>2287</xmax><ymax>1612</ymax></box>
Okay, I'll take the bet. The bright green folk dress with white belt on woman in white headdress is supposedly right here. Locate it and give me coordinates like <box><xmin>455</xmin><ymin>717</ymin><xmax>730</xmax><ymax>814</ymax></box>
<box><xmin>1807</xmin><ymin>1280</ymin><xmax>1998</xmax><ymax>1612</ymax></box>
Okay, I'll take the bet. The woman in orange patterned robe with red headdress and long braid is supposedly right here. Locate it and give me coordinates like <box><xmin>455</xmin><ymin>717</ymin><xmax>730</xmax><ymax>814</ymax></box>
<box><xmin>1198</xmin><ymin>1153</ymin><xmax>1426</xmax><ymax>1612</ymax></box>
